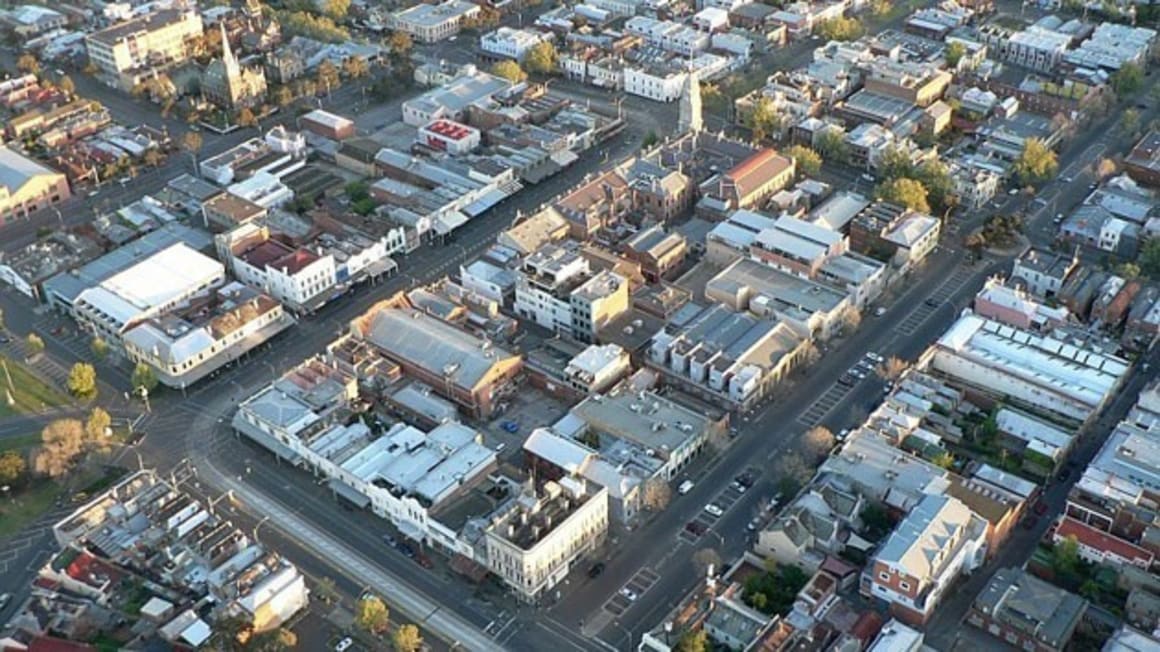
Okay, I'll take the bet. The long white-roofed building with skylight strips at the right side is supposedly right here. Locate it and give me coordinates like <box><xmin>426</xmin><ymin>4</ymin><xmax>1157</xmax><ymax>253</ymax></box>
<box><xmin>923</xmin><ymin>314</ymin><xmax>1129</xmax><ymax>422</ymax></box>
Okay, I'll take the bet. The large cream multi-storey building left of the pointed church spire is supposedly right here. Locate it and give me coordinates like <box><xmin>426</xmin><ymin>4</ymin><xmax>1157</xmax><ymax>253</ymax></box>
<box><xmin>85</xmin><ymin>9</ymin><xmax>203</xmax><ymax>92</ymax></box>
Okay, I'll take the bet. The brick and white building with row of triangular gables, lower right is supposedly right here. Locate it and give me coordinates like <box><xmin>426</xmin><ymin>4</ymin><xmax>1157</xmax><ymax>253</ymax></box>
<box><xmin>862</xmin><ymin>495</ymin><xmax>987</xmax><ymax>626</ymax></box>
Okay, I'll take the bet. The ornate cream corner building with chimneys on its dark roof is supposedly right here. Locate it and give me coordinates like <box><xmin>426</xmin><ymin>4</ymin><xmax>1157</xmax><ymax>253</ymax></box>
<box><xmin>485</xmin><ymin>477</ymin><xmax>608</xmax><ymax>603</ymax></box>
